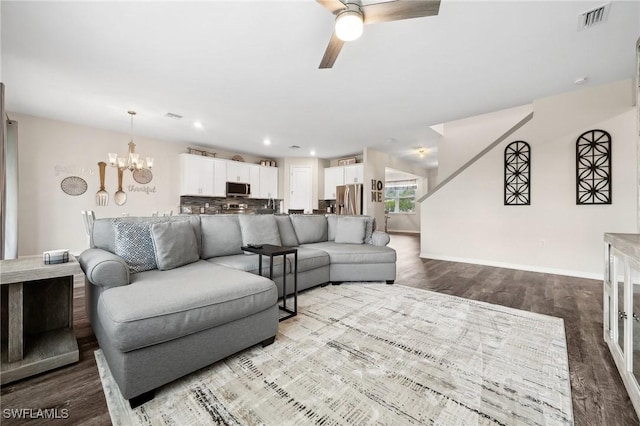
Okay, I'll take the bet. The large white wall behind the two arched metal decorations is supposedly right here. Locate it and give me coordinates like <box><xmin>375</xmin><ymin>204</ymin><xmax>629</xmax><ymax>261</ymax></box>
<box><xmin>421</xmin><ymin>80</ymin><xmax>638</xmax><ymax>278</ymax></box>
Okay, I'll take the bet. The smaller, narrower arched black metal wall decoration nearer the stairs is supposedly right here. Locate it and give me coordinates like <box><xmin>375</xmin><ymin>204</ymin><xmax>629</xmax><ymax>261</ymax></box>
<box><xmin>504</xmin><ymin>141</ymin><xmax>531</xmax><ymax>206</ymax></box>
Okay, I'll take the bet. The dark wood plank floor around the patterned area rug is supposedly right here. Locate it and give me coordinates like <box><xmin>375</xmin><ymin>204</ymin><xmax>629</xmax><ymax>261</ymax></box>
<box><xmin>0</xmin><ymin>234</ymin><xmax>640</xmax><ymax>426</ymax></box>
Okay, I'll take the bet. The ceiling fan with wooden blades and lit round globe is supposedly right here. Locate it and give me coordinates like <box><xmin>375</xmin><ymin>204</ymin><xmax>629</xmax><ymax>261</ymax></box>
<box><xmin>316</xmin><ymin>0</ymin><xmax>440</xmax><ymax>68</ymax></box>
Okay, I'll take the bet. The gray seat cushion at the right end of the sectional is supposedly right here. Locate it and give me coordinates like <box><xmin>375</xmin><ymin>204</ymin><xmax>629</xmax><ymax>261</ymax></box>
<box><xmin>304</xmin><ymin>242</ymin><xmax>396</xmax><ymax>264</ymax></box>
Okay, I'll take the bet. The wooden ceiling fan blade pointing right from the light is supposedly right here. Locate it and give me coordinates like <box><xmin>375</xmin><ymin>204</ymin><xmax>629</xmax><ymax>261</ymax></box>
<box><xmin>362</xmin><ymin>0</ymin><xmax>440</xmax><ymax>24</ymax></box>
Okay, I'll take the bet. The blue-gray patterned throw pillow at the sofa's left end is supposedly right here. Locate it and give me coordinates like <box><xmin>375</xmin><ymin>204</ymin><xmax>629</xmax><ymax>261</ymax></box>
<box><xmin>112</xmin><ymin>218</ymin><xmax>162</xmax><ymax>274</ymax></box>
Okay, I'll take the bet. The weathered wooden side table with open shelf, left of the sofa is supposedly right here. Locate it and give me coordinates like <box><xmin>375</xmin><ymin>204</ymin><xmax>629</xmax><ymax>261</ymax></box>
<box><xmin>0</xmin><ymin>256</ymin><xmax>84</xmax><ymax>384</ymax></box>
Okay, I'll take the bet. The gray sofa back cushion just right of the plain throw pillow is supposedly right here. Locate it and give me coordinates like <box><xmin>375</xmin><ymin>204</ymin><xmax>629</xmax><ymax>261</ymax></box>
<box><xmin>200</xmin><ymin>214</ymin><xmax>242</xmax><ymax>259</ymax></box>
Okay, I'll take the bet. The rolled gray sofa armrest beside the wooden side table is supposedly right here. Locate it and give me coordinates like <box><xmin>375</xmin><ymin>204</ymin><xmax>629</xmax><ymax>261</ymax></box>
<box><xmin>78</xmin><ymin>249</ymin><xmax>130</xmax><ymax>287</ymax></box>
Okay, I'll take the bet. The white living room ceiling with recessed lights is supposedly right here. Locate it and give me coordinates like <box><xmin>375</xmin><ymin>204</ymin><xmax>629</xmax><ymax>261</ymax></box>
<box><xmin>1</xmin><ymin>0</ymin><xmax>640</xmax><ymax>166</ymax></box>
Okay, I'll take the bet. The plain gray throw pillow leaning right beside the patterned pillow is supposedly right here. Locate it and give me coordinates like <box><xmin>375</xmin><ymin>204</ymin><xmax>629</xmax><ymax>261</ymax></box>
<box><xmin>151</xmin><ymin>221</ymin><xmax>200</xmax><ymax>271</ymax></box>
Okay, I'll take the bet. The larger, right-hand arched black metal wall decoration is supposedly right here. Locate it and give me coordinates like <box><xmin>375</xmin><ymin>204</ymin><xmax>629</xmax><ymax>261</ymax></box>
<box><xmin>576</xmin><ymin>130</ymin><xmax>611</xmax><ymax>205</ymax></box>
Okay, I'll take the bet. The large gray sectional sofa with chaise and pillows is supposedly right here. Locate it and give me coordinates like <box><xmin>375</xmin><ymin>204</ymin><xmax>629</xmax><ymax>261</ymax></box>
<box><xmin>78</xmin><ymin>215</ymin><xmax>396</xmax><ymax>407</ymax></box>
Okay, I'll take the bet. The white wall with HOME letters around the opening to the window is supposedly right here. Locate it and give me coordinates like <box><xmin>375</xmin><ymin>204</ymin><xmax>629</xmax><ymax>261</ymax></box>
<box><xmin>363</xmin><ymin>148</ymin><xmax>429</xmax><ymax>232</ymax></box>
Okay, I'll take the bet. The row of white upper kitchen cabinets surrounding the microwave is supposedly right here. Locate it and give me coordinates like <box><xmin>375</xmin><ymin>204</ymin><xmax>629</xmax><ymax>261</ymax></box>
<box><xmin>180</xmin><ymin>154</ymin><xmax>278</xmax><ymax>199</ymax></box>
